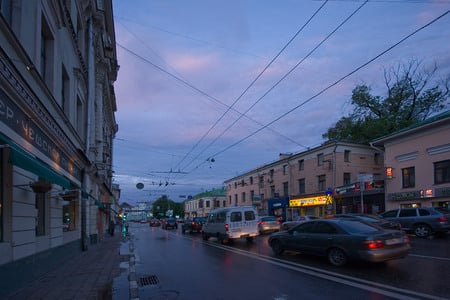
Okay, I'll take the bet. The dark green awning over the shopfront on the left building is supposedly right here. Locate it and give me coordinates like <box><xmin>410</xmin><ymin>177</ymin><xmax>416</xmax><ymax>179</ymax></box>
<box><xmin>0</xmin><ymin>135</ymin><xmax>70</xmax><ymax>189</ymax></box>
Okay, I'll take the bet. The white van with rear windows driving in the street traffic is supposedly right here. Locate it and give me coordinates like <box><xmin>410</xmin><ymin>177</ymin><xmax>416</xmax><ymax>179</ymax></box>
<box><xmin>202</xmin><ymin>206</ymin><xmax>259</xmax><ymax>243</ymax></box>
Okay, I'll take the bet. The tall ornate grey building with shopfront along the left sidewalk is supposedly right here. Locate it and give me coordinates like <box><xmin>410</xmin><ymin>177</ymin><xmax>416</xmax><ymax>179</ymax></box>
<box><xmin>0</xmin><ymin>0</ymin><xmax>118</xmax><ymax>273</ymax></box>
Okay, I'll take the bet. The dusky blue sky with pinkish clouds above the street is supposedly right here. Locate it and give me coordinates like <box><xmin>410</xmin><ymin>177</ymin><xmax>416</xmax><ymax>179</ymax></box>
<box><xmin>113</xmin><ymin>0</ymin><xmax>450</xmax><ymax>204</ymax></box>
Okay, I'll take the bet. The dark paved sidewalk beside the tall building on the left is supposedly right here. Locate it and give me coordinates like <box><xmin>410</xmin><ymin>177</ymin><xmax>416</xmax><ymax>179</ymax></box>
<box><xmin>2</xmin><ymin>232</ymin><xmax>132</xmax><ymax>300</ymax></box>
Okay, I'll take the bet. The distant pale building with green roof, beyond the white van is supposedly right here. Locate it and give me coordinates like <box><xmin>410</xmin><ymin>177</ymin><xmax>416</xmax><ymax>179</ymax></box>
<box><xmin>184</xmin><ymin>189</ymin><xmax>227</xmax><ymax>219</ymax></box>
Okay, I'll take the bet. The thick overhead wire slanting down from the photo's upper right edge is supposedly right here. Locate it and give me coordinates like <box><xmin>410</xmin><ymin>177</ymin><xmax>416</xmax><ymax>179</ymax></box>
<box><xmin>188</xmin><ymin>10</ymin><xmax>450</xmax><ymax>173</ymax></box>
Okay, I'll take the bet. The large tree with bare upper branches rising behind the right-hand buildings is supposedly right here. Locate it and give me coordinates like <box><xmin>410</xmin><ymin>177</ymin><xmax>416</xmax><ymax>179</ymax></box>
<box><xmin>322</xmin><ymin>60</ymin><xmax>450</xmax><ymax>143</ymax></box>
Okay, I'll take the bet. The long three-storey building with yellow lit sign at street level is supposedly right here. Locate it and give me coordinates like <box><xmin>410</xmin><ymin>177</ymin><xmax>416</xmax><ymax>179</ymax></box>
<box><xmin>225</xmin><ymin>142</ymin><xmax>384</xmax><ymax>220</ymax></box>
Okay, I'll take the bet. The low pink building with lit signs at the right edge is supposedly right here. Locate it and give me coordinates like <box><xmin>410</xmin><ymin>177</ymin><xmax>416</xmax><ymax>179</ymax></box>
<box><xmin>372</xmin><ymin>111</ymin><xmax>450</xmax><ymax>209</ymax></box>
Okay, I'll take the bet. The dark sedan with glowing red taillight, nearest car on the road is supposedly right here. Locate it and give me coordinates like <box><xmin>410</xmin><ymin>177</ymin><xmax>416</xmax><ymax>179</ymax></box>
<box><xmin>268</xmin><ymin>218</ymin><xmax>411</xmax><ymax>266</ymax></box>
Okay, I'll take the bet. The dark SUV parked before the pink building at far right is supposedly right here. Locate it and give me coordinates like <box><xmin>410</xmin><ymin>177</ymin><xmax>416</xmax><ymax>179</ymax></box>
<box><xmin>380</xmin><ymin>207</ymin><xmax>450</xmax><ymax>238</ymax></box>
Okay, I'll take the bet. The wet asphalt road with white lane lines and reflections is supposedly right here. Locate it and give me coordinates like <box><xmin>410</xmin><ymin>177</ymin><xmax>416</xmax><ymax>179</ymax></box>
<box><xmin>130</xmin><ymin>224</ymin><xmax>450</xmax><ymax>300</ymax></box>
